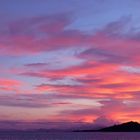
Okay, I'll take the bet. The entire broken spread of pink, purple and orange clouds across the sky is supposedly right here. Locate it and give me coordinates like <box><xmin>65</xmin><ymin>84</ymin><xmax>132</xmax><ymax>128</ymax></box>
<box><xmin>0</xmin><ymin>15</ymin><xmax>140</xmax><ymax>123</ymax></box>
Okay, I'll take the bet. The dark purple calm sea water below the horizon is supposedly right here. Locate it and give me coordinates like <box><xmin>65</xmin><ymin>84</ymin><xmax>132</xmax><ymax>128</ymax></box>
<box><xmin>0</xmin><ymin>132</ymin><xmax>140</xmax><ymax>140</ymax></box>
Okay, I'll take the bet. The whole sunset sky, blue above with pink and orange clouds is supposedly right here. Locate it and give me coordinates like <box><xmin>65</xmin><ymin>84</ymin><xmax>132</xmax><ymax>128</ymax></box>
<box><xmin>0</xmin><ymin>0</ymin><xmax>140</xmax><ymax>128</ymax></box>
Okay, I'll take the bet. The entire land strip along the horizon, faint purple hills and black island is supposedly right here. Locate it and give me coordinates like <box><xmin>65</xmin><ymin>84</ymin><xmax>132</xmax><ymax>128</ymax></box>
<box><xmin>0</xmin><ymin>121</ymin><xmax>140</xmax><ymax>133</ymax></box>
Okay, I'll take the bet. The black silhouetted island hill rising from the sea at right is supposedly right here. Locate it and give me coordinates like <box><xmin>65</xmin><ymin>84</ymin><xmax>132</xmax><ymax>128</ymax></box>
<box><xmin>77</xmin><ymin>121</ymin><xmax>140</xmax><ymax>132</ymax></box>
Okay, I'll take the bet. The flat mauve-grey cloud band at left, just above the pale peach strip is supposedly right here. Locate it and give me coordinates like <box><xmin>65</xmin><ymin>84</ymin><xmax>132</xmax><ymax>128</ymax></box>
<box><xmin>0</xmin><ymin>94</ymin><xmax>69</xmax><ymax>108</ymax></box>
